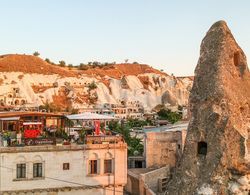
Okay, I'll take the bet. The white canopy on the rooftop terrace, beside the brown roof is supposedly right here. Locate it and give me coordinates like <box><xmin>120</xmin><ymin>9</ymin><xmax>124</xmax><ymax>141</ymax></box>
<box><xmin>66</xmin><ymin>112</ymin><xmax>116</xmax><ymax>120</ymax></box>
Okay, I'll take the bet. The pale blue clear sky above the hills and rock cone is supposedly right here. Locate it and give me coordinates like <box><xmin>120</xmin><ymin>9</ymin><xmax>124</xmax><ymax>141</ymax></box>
<box><xmin>0</xmin><ymin>0</ymin><xmax>250</xmax><ymax>76</ymax></box>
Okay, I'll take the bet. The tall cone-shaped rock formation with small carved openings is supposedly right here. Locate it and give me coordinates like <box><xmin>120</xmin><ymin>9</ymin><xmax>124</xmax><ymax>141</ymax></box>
<box><xmin>167</xmin><ymin>21</ymin><xmax>250</xmax><ymax>195</ymax></box>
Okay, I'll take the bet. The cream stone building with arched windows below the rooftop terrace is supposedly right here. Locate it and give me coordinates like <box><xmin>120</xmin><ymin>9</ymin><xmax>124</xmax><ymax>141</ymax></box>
<box><xmin>0</xmin><ymin>136</ymin><xmax>127</xmax><ymax>195</ymax></box>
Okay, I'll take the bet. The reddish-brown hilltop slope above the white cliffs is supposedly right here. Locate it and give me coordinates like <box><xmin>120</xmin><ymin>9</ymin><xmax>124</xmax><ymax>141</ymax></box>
<box><xmin>0</xmin><ymin>54</ymin><xmax>164</xmax><ymax>79</ymax></box>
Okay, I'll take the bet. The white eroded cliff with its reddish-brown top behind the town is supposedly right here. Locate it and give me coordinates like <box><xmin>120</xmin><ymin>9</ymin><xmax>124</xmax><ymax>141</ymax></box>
<box><xmin>0</xmin><ymin>54</ymin><xmax>193</xmax><ymax>110</ymax></box>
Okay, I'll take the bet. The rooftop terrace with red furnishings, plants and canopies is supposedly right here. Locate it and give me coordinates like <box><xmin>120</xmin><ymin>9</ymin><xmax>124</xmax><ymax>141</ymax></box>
<box><xmin>0</xmin><ymin>112</ymin><xmax>124</xmax><ymax>147</ymax></box>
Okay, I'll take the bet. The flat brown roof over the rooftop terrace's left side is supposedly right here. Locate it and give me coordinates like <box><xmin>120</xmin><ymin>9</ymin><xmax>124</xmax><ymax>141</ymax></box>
<box><xmin>0</xmin><ymin>111</ymin><xmax>63</xmax><ymax>118</ymax></box>
